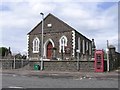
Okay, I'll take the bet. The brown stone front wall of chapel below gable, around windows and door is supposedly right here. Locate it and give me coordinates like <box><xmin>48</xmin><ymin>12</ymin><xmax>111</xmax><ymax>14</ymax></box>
<box><xmin>28</xmin><ymin>31</ymin><xmax>72</xmax><ymax>59</ymax></box>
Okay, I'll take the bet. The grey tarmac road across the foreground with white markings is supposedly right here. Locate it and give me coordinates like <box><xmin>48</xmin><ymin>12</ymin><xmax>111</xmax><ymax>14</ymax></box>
<box><xmin>2</xmin><ymin>73</ymin><xmax>118</xmax><ymax>88</ymax></box>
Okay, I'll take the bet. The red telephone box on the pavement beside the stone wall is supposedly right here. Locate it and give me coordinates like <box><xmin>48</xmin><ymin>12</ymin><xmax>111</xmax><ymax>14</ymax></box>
<box><xmin>95</xmin><ymin>50</ymin><xmax>104</xmax><ymax>72</ymax></box>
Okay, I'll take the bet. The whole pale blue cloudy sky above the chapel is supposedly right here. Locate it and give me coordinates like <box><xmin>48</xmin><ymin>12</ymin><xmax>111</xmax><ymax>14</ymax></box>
<box><xmin>0</xmin><ymin>0</ymin><xmax>118</xmax><ymax>53</ymax></box>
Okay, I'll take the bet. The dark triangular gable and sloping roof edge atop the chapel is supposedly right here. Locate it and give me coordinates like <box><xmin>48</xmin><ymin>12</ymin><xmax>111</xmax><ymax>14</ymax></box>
<box><xmin>28</xmin><ymin>13</ymin><xmax>92</xmax><ymax>40</ymax></box>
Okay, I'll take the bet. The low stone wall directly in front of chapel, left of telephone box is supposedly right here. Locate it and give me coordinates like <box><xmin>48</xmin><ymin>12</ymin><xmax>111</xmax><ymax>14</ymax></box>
<box><xmin>29</xmin><ymin>61</ymin><xmax>94</xmax><ymax>71</ymax></box>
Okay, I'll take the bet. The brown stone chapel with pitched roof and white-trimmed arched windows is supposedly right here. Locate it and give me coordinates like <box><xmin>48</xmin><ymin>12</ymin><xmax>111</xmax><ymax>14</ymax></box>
<box><xmin>27</xmin><ymin>14</ymin><xmax>92</xmax><ymax>61</ymax></box>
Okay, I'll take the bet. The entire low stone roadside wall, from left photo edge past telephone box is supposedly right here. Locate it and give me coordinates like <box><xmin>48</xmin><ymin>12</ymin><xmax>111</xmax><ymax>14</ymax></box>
<box><xmin>0</xmin><ymin>60</ymin><xmax>107</xmax><ymax>71</ymax></box>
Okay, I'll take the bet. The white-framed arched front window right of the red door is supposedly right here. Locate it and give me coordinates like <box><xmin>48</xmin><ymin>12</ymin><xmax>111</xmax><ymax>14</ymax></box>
<box><xmin>59</xmin><ymin>36</ymin><xmax>67</xmax><ymax>53</ymax></box>
